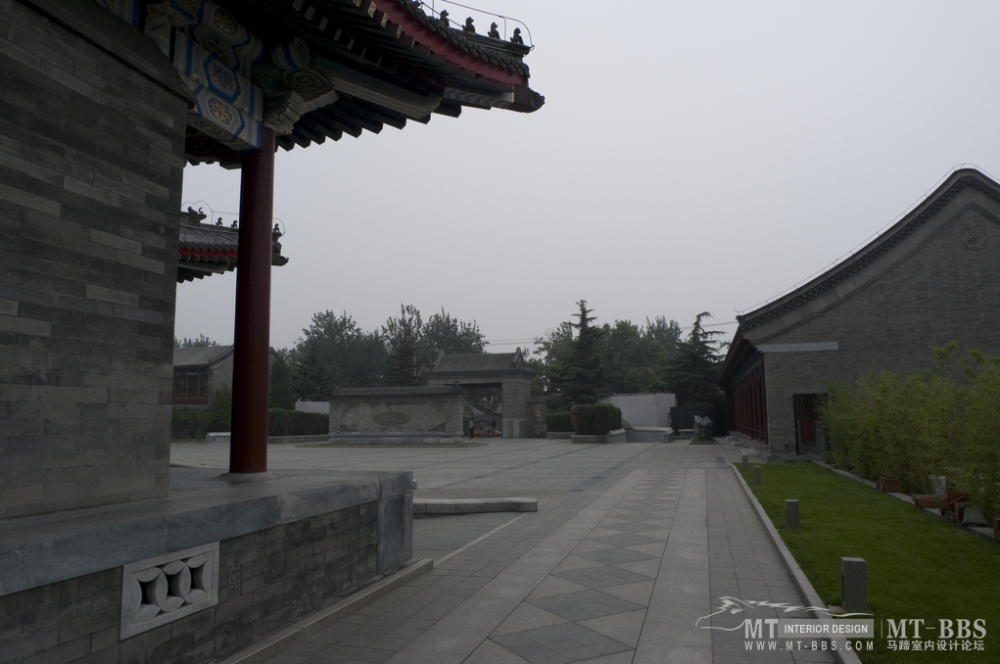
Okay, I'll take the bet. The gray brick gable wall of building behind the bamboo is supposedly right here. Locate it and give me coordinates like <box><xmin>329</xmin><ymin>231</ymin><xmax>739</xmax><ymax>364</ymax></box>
<box><xmin>746</xmin><ymin>187</ymin><xmax>1000</xmax><ymax>452</ymax></box>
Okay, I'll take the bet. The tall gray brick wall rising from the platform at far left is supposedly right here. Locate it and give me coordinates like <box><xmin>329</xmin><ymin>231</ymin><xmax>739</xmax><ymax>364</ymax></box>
<box><xmin>0</xmin><ymin>0</ymin><xmax>186</xmax><ymax>520</ymax></box>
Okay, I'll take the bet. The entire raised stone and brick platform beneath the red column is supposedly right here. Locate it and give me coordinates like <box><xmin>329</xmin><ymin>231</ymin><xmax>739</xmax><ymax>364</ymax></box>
<box><xmin>0</xmin><ymin>468</ymin><xmax>413</xmax><ymax>664</ymax></box>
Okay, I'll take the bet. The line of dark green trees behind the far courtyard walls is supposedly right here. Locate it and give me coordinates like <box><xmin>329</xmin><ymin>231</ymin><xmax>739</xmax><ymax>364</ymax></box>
<box><xmin>175</xmin><ymin>300</ymin><xmax>724</xmax><ymax>409</ymax></box>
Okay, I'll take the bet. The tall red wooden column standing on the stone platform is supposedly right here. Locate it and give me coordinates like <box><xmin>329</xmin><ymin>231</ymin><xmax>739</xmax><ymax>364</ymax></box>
<box><xmin>229</xmin><ymin>127</ymin><xmax>274</xmax><ymax>473</ymax></box>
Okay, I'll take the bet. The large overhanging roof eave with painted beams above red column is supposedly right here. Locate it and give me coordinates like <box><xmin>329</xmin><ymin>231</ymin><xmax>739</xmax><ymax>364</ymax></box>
<box><xmin>96</xmin><ymin>0</ymin><xmax>545</xmax><ymax>166</ymax></box>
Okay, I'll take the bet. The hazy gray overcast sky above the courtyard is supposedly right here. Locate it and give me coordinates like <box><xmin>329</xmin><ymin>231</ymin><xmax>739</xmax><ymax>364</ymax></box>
<box><xmin>176</xmin><ymin>0</ymin><xmax>1000</xmax><ymax>352</ymax></box>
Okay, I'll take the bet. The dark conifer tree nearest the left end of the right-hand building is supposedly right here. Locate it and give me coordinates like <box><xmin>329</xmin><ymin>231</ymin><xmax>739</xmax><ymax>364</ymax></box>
<box><xmin>666</xmin><ymin>311</ymin><xmax>723</xmax><ymax>406</ymax></box>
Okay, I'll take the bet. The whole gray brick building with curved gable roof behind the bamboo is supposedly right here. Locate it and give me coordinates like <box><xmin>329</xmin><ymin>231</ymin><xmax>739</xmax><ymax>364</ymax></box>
<box><xmin>719</xmin><ymin>169</ymin><xmax>1000</xmax><ymax>456</ymax></box>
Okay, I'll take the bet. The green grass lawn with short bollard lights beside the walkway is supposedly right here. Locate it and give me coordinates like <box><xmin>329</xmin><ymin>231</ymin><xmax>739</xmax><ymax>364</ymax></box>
<box><xmin>740</xmin><ymin>463</ymin><xmax>1000</xmax><ymax>664</ymax></box>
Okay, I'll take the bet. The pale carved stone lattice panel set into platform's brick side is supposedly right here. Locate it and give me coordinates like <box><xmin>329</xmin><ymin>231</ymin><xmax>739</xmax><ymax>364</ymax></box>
<box><xmin>121</xmin><ymin>542</ymin><xmax>219</xmax><ymax>639</ymax></box>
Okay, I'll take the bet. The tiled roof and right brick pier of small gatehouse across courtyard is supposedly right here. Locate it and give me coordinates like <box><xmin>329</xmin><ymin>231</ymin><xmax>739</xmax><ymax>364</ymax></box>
<box><xmin>420</xmin><ymin>348</ymin><xmax>535</xmax><ymax>438</ymax></box>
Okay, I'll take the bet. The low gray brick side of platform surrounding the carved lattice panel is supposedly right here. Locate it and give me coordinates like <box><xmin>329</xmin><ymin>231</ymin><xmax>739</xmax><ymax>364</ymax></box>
<box><xmin>0</xmin><ymin>502</ymin><xmax>378</xmax><ymax>664</ymax></box>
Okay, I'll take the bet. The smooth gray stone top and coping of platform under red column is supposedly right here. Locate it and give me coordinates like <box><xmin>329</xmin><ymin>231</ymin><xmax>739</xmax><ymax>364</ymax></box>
<box><xmin>0</xmin><ymin>467</ymin><xmax>413</xmax><ymax>595</ymax></box>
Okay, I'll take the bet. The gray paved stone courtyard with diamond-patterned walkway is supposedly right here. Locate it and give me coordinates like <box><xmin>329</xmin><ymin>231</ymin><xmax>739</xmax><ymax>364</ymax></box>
<box><xmin>172</xmin><ymin>439</ymin><xmax>833</xmax><ymax>664</ymax></box>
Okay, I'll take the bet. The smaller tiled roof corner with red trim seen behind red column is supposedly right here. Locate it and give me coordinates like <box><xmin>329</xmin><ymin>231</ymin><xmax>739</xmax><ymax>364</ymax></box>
<box><xmin>177</xmin><ymin>208</ymin><xmax>288</xmax><ymax>282</ymax></box>
